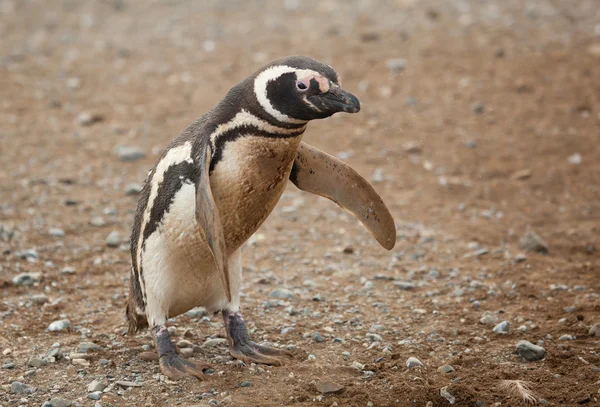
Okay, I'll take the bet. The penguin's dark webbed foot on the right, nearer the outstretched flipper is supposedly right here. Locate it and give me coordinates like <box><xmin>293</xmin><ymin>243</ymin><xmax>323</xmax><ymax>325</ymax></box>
<box><xmin>223</xmin><ymin>311</ymin><xmax>293</xmax><ymax>366</ymax></box>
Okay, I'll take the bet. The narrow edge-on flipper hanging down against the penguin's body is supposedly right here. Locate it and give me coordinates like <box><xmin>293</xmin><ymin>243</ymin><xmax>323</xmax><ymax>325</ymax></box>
<box><xmin>196</xmin><ymin>145</ymin><xmax>231</xmax><ymax>302</ymax></box>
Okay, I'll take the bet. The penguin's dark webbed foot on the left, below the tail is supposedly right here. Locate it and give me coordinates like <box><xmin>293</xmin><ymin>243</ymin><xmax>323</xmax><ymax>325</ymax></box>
<box><xmin>152</xmin><ymin>325</ymin><xmax>210</xmax><ymax>380</ymax></box>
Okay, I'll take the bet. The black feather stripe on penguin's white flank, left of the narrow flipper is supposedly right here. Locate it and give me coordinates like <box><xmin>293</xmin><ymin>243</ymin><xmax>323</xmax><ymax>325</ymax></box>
<box><xmin>142</xmin><ymin>161</ymin><xmax>199</xmax><ymax>250</ymax></box>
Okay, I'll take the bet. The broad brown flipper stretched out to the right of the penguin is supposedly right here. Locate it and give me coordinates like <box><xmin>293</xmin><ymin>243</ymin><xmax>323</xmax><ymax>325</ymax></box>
<box><xmin>290</xmin><ymin>142</ymin><xmax>396</xmax><ymax>250</ymax></box>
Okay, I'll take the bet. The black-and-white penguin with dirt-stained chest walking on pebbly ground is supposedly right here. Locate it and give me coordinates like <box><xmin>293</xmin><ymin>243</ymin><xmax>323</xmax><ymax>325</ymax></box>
<box><xmin>126</xmin><ymin>56</ymin><xmax>396</xmax><ymax>378</ymax></box>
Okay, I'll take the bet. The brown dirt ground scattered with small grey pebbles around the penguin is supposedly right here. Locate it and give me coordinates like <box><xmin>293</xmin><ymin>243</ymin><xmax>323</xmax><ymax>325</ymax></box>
<box><xmin>0</xmin><ymin>0</ymin><xmax>600</xmax><ymax>407</ymax></box>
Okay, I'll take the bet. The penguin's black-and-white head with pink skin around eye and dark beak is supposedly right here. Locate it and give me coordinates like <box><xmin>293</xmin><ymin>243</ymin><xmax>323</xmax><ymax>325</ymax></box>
<box><xmin>254</xmin><ymin>56</ymin><xmax>360</xmax><ymax>123</ymax></box>
